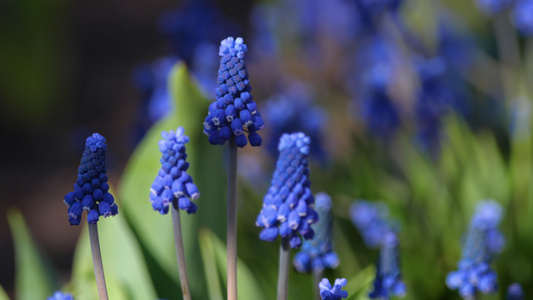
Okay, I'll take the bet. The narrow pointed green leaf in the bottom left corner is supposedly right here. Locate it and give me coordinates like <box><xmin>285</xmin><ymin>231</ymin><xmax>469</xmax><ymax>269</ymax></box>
<box><xmin>7</xmin><ymin>209</ymin><xmax>57</xmax><ymax>300</ymax></box>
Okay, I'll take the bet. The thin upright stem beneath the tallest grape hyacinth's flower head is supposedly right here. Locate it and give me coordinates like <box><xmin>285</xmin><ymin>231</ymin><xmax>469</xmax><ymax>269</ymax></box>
<box><xmin>226</xmin><ymin>135</ymin><xmax>238</xmax><ymax>300</ymax></box>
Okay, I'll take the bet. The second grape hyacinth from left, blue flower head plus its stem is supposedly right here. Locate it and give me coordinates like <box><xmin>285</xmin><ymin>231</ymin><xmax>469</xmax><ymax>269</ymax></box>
<box><xmin>150</xmin><ymin>127</ymin><xmax>200</xmax><ymax>300</ymax></box>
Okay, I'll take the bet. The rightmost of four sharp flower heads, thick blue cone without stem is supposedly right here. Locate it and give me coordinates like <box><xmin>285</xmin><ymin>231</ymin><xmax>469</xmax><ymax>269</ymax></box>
<box><xmin>255</xmin><ymin>132</ymin><xmax>318</xmax><ymax>248</ymax></box>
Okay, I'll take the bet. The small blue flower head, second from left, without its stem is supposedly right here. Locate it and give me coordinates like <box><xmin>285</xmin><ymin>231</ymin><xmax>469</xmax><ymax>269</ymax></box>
<box><xmin>150</xmin><ymin>127</ymin><xmax>200</xmax><ymax>215</ymax></box>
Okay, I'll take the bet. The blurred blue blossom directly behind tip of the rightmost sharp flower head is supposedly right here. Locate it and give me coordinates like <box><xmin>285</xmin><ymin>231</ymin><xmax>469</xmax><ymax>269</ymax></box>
<box><xmin>264</xmin><ymin>83</ymin><xmax>327</xmax><ymax>161</ymax></box>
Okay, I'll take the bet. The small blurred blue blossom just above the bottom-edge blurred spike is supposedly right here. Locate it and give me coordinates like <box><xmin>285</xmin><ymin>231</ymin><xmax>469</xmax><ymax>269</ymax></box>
<box><xmin>350</xmin><ymin>200</ymin><xmax>392</xmax><ymax>249</ymax></box>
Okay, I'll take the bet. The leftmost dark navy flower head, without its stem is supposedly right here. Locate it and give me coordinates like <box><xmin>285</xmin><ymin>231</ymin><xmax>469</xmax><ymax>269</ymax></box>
<box><xmin>64</xmin><ymin>133</ymin><xmax>118</xmax><ymax>225</ymax></box>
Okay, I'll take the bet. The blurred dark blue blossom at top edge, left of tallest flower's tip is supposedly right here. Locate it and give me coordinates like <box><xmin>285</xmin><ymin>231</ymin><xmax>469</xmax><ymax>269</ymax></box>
<box><xmin>159</xmin><ymin>0</ymin><xmax>235</xmax><ymax>63</ymax></box>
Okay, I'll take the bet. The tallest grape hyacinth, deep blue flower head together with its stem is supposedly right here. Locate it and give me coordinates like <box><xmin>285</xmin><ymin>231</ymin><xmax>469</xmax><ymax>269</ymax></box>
<box><xmin>204</xmin><ymin>37</ymin><xmax>264</xmax><ymax>300</ymax></box>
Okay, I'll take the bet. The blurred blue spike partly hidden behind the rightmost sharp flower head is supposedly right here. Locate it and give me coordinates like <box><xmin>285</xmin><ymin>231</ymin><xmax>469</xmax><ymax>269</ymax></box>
<box><xmin>293</xmin><ymin>193</ymin><xmax>339</xmax><ymax>273</ymax></box>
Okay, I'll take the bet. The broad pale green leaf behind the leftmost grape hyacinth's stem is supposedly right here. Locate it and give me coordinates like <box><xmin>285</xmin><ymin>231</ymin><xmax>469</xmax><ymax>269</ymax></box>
<box><xmin>72</xmin><ymin>214</ymin><xmax>156</xmax><ymax>300</ymax></box>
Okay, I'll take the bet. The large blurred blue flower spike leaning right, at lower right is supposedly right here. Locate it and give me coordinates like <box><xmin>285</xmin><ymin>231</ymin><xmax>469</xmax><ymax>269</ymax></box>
<box><xmin>446</xmin><ymin>200</ymin><xmax>505</xmax><ymax>299</ymax></box>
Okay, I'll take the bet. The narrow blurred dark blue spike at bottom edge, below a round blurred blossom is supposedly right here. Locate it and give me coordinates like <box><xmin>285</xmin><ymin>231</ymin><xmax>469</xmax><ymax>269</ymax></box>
<box><xmin>368</xmin><ymin>232</ymin><xmax>407</xmax><ymax>299</ymax></box>
